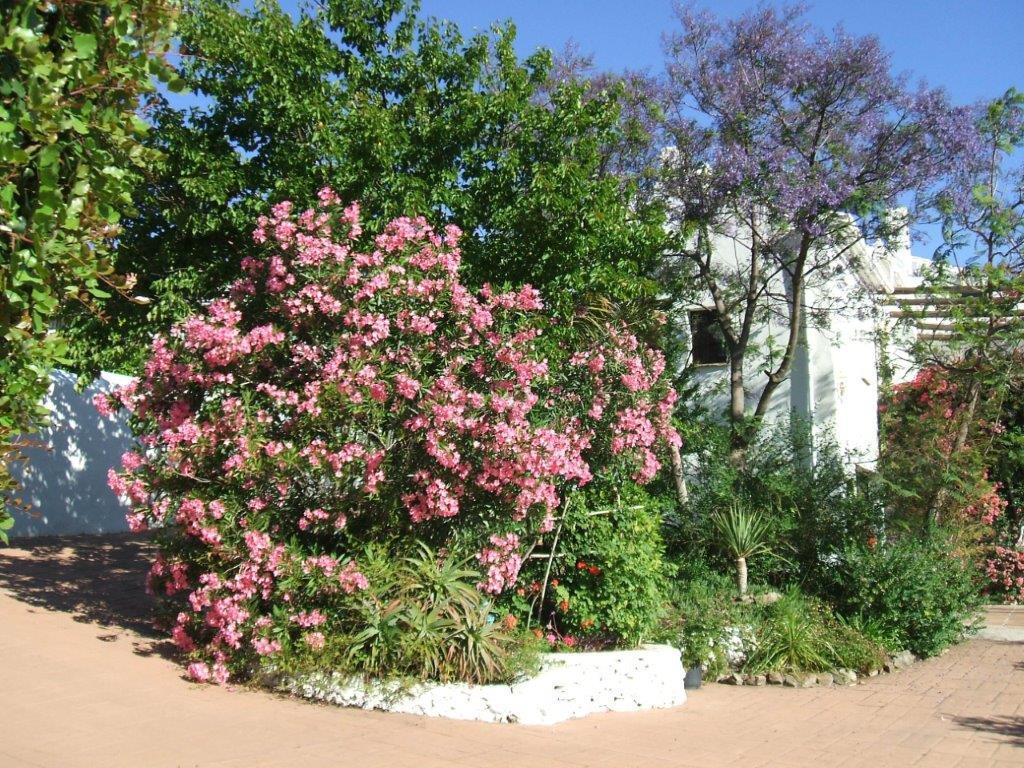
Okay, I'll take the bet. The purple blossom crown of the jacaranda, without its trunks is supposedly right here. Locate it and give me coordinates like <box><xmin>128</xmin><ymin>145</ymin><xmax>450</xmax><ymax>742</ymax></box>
<box><xmin>665</xmin><ymin>6</ymin><xmax>977</xmax><ymax>238</ymax></box>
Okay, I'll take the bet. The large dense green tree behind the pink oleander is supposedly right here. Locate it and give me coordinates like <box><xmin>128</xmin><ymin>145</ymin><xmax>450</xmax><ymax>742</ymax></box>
<box><xmin>70</xmin><ymin>0</ymin><xmax>663</xmax><ymax>371</ymax></box>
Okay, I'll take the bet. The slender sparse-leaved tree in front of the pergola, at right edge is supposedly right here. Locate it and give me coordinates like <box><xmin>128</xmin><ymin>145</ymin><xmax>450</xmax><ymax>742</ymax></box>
<box><xmin>890</xmin><ymin>89</ymin><xmax>1024</xmax><ymax>525</ymax></box>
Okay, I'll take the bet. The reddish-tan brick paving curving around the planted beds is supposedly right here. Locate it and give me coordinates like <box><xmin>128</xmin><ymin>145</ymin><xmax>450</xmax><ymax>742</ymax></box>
<box><xmin>0</xmin><ymin>537</ymin><xmax>1024</xmax><ymax>768</ymax></box>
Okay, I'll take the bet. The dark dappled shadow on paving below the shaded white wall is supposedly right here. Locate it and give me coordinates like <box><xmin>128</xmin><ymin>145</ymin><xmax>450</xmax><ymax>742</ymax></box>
<box><xmin>0</xmin><ymin>534</ymin><xmax>171</xmax><ymax>653</ymax></box>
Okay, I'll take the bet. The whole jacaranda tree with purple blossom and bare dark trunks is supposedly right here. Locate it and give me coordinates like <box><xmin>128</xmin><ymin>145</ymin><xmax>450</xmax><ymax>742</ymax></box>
<box><xmin>665</xmin><ymin>6</ymin><xmax>975</xmax><ymax>459</ymax></box>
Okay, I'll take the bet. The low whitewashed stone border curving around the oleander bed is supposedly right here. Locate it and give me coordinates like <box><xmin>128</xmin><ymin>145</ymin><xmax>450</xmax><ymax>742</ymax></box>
<box><xmin>278</xmin><ymin>645</ymin><xmax>686</xmax><ymax>725</ymax></box>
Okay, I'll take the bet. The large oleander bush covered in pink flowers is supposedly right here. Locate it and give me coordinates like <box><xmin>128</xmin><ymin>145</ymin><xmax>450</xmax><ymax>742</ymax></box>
<box><xmin>97</xmin><ymin>189</ymin><xmax>679</xmax><ymax>682</ymax></box>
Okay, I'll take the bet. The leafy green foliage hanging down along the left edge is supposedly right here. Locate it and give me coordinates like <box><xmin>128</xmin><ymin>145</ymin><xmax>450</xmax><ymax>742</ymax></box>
<box><xmin>0</xmin><ymin>0</ymin><xmax>176</xmax><ymax>536</ymax></box>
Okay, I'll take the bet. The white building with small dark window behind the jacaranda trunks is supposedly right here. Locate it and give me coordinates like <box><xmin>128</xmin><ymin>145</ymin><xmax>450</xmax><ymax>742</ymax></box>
<box><xmin>687</xmin><ymin>219</ymin><xmax>930</xmax><ymax>470</ymax></box>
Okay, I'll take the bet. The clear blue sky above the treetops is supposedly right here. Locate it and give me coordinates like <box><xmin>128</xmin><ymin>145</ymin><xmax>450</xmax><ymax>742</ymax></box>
<box><xmin>423</xmin><ymin>0</ymin><xmax>1024</xmax><ymax>102</ymax></box>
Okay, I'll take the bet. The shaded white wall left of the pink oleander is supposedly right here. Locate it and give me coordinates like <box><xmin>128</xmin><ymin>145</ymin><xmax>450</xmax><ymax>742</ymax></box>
<box><xmin>10</xmin><ymin>371</ymin><xmax>132</xmax><ymax>537</ymax></box>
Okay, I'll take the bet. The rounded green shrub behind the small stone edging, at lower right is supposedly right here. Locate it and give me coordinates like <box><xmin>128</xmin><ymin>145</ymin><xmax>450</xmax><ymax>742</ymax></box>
<box><xmin>817</xmin><ymin>539</ymin><xmax>981</xmax><ymax>656</ymax></box>
